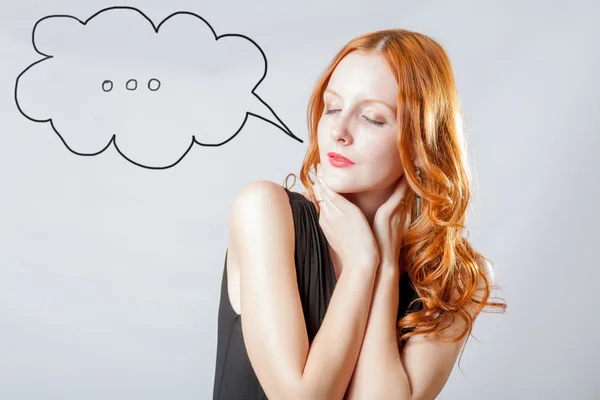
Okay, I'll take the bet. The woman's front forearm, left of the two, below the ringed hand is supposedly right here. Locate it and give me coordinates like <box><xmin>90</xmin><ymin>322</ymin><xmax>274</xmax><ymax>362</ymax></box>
<box><xmin>301</xmin><ymin>266</ymin><xmax>376</xmax><ymax>400</ymax></box>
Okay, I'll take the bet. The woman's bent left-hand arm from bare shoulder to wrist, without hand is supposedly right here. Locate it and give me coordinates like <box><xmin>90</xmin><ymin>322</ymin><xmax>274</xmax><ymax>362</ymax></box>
<box><xmin>230</xmin><ymin>181</ymin><xmax>376</xmax><ymax>400</ymax></box>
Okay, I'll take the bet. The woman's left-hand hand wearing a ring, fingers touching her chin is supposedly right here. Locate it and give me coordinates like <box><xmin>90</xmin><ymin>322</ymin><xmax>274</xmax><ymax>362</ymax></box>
<box><xmin>315</xmin><ymin>164</ymin><xmax>379</xmax><ymax>268</ymax></box>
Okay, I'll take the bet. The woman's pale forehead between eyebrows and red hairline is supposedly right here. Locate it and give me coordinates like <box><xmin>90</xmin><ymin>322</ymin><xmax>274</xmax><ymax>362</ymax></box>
<box><xmin>328</xmin><ymin>51</ymin><xmax>398</xmax><ymax>104</ymax></box>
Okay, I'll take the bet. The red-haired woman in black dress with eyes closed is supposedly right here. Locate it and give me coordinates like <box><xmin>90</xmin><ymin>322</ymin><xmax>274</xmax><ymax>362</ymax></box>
<box><xmin>213</xmin><ymin>30</ymin><xmax>506</xmax><ymax>400</ymax></box>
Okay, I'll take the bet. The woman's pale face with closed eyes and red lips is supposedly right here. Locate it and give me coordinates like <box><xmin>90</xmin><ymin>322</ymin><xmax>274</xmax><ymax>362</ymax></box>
<box><xmin>318</xmin><ymin>52</ymin><xmax>403</xmax><ymax>193</ymax></box>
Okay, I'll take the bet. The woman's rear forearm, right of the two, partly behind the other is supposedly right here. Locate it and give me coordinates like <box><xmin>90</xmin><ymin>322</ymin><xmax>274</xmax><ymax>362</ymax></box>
<box><xmin>346</xmin><ymin>266</ymin><xmax>410</xmax><ymax>400</ymax></box>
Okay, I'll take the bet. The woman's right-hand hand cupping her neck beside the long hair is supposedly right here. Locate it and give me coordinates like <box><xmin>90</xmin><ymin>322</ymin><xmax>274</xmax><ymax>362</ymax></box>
<box><xmin>373</xmin><ymin>175</ymin><xmax>410</xmax><ymax>273</ymax></box>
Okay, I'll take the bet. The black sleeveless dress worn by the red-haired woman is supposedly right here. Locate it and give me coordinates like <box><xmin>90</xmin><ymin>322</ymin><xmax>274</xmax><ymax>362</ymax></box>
<box><xmin>213</xmin><ymin>188</ymin><xmax>422</xmax><ymax>400</ymax></box>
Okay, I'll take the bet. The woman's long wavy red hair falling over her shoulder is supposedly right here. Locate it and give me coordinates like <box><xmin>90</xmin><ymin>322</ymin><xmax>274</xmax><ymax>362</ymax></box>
<box><xmin>284</xmin><ymin>29</ymin><xmax>506</xmax><ymax>370</ymax></box>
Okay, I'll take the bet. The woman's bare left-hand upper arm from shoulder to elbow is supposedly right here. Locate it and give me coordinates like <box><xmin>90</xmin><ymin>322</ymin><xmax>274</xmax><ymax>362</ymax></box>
<box><xmin>225</xmin><ymin>181</ymin><xmax>309</xmax><ymax>398</ymax></box>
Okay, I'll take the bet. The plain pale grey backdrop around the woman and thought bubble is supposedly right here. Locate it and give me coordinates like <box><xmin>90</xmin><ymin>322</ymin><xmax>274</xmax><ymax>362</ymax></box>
<box><xmin>0</xmin><ymin>0</ymin><xmax>600</xmax><ymax>400</ymax></box>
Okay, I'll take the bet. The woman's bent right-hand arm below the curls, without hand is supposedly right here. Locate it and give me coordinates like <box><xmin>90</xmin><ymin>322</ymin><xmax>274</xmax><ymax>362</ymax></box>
<box><xmin>346</xmin><ymin>265</ymin><xmax>493</xmax><ymax>400</ymax></box>
